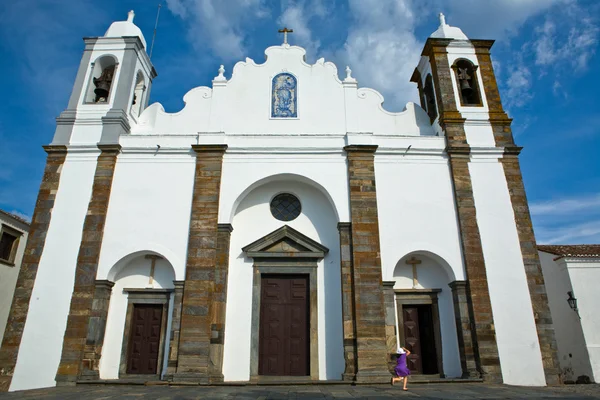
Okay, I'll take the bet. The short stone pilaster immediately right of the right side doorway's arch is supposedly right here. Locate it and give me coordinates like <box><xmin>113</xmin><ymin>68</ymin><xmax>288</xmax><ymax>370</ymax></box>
<box><xmin>448</xmin><ymin>281</ymin><xmax>480</xmax><ymax>379</ymax></box>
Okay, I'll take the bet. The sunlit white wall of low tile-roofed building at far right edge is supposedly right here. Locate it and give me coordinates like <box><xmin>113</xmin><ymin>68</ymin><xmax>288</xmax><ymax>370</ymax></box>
<box><xmin>560</xmin><ymin>258</ymin><xmax>600</xmax><ymax>382</ymax></box>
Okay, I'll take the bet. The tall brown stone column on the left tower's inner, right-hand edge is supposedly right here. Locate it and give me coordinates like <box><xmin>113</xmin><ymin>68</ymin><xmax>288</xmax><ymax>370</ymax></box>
<box><xmin>56</xmin><ymin>144</ymin><xmax>121</xmax><ymax>385</ymax></box>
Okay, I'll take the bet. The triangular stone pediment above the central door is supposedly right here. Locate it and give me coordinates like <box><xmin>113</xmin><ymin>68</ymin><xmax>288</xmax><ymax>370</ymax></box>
<box><xmin>242</xmin><ymin>225</ymin><xmax>329</xmax><ymax>259</ymax></box>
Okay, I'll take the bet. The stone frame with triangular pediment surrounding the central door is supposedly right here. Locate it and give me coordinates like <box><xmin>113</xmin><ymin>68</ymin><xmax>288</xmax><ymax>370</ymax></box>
<box><xmin>242</xmin><ymin>225</ymin><xmax>329</xmax><ymax>382</ymax></box>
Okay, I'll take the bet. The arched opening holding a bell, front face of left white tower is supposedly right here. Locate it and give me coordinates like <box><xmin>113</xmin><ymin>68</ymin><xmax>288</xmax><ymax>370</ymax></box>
<box><xmin>84</xmin><ymin>54</ymin><xmax>118</xmax><ymax>104</ymax></box>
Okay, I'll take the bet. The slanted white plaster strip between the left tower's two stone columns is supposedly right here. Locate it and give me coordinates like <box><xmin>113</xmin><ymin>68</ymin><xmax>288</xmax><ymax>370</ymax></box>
<box><xmin>10</xmin><ymin>152</ymin><xmax>98</xmax><ymax>391</ymax></box>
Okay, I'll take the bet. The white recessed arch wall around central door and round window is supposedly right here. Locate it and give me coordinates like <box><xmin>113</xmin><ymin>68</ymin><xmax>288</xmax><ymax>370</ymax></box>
<box><xmin>223</xmin><ymin>179</ymin><xmax>344</xmax><ymax>382</ymax></box>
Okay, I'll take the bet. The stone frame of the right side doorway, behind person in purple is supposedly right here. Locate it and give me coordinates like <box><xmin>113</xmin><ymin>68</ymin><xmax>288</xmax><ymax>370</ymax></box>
<box><xmin>394</xmin><ymin>289</ymin><xmax>446</xmax><ymax>378</ymax></box>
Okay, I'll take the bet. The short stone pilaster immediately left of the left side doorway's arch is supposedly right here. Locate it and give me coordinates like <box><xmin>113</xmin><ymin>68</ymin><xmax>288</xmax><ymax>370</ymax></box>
<box><xmin>81</xmin><ymin>280</ymin><xmax>115</xmax><ymax>380</ymax></box>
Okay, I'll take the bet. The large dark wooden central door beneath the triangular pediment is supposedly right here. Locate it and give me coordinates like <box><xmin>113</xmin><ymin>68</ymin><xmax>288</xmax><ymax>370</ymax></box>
<box><xmin>258</xmin><ymin>275</ymin><xmax>310</xmax><ymax>376</ymax></box>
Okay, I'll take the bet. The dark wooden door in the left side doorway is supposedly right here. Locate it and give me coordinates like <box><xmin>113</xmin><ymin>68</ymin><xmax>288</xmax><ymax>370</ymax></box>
<box><xmin>127</xmin><ymin>304</ymin><xmax>163</xmax><ymax>374</ymax></box>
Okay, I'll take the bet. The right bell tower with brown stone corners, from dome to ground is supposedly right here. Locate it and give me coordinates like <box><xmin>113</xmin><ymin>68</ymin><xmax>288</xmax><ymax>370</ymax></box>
<box><xmin>411</xmin><ymin>14</ymin><xmax>559</xmax><ymax>385</ymax></box>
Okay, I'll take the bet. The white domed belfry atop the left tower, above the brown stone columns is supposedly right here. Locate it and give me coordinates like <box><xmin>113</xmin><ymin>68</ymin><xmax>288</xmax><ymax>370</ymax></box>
<box><xmin>52</xmin><ymin>11</ymin><xmax>156</xmax><ymax>145</ymax></box>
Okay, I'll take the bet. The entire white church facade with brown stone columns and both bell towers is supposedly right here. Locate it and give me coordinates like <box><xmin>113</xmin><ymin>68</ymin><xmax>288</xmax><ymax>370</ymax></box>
<box><xmin>0</xmin><ymin>10</ymin><xmax>559</xmax><ymax>390</ymax></box>
